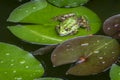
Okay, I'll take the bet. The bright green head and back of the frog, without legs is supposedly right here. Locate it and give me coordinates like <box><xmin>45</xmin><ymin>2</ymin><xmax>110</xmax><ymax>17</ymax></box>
<box><xmin>56</xmin><ymin>17</ymin><xmax>79</xmax><ymax>36</ymax></box>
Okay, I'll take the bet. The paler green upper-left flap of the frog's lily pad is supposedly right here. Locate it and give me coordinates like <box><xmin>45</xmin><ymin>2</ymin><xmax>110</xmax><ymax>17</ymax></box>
<box><xmin>7</xmin><ymin>0</ymin><xmax>47</xmax><ymax>23</ymax></box>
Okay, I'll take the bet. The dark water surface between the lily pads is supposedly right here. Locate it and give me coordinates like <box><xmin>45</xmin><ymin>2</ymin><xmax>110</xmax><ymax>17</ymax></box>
<box><xmin>0</xmin><ymin>0</ymin><xmax>120</xmax><ymax>80</ymax></box>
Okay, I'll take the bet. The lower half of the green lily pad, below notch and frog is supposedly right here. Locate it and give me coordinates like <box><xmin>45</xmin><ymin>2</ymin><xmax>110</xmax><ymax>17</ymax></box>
<box><xmin>8</xmin><ymin>22</ymin><xmax>100</xmax><ymax>45</ymax></box>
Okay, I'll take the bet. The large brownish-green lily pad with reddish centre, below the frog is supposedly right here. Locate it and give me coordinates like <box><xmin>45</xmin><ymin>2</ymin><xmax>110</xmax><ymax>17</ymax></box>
<box><xmin>51</xmin><ymin>35</ymin><xmax>120</xmax><ymax>75</ymax></box>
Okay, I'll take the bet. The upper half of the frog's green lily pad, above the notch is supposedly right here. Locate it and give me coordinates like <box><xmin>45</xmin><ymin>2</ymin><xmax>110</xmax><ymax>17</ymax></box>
<box><xmin>7</xmin><ymin>0</ymin><xmax>101</xmax><ymax>24</ymax></box>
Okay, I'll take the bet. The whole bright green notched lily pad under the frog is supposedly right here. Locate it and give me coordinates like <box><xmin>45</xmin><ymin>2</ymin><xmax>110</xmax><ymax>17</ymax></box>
<box><xmin>8</xmin><ymin>0</ymin><xmax>101</xmax><ymax>45</ymax></box>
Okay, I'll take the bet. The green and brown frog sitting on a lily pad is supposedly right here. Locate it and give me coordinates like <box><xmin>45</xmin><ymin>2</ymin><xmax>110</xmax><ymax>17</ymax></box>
<box><xmin>56</xmin><ymin>13</ymin><xmax>90</xmax><ymax>36</ymax></box>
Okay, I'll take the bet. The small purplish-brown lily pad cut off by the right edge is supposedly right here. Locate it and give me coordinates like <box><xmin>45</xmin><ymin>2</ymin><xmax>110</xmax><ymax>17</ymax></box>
<box><xmin>103</xmin><ymin>14</ymin><xmax>120</xmax><ymax>39</ymax></box>
